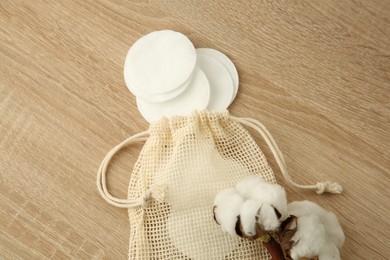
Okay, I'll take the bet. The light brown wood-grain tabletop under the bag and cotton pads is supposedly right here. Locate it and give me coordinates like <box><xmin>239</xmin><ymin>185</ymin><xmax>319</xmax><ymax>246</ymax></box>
<box><xmin>0</xmin><ymin>0</ymin><xmax>390</xmax><ymax>259</ymax></box>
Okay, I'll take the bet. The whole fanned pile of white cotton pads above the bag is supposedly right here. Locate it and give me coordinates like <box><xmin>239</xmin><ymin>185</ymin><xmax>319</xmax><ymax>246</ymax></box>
<box><xmin>124</xmin><ymin>30</ymin><xmax>238</xmax><ymax>122</ymax></box>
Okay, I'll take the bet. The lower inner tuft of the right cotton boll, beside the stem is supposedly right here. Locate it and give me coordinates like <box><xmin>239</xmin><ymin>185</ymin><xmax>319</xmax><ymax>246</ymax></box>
<box><xmin>290</xmin><ymin>214</ymin><xmax>327</xmax><ymax>260</ymax></box>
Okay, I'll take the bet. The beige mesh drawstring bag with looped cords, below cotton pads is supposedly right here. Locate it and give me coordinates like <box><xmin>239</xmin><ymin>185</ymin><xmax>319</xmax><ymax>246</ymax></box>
<box><xmin>98</xmin><ymin>111</ymin><xmax>340</xmax><ymax>260</ymax></box>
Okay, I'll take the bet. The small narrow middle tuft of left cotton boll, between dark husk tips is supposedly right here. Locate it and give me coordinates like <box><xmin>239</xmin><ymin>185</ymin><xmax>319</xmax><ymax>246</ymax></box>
<box><xmin>240</xmin><ymin>199</ymin><xmax>262</xmax><ymax>238</ymax></box>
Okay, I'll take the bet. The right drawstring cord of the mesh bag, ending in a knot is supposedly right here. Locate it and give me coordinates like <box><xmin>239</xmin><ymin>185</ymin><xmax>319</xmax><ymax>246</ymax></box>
<box><xmin>230</xmin><ymin>116</ymin><xmax>343</xmax><ymax>194</ymax></box>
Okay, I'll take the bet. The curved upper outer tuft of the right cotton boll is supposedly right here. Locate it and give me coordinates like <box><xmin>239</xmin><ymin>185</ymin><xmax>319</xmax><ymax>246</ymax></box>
<box><xmin>288</xmin><ymin>200</ymin><xmax>345</xmax><ymax>249</ymax></box>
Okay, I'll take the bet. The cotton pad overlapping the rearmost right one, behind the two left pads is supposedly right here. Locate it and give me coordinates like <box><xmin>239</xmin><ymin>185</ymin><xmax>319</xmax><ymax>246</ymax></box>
<box><xmin>197</xmin><ymin>51</ymin><xmax>234</xmax><ymax>112</ymax></box>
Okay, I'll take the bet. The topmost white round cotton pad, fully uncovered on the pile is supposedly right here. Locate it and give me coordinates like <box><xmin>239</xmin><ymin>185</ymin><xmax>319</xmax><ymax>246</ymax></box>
<box><xmin>124</xmin><ymin>30</ymin><xmax>196</xmax><ymax>99</ymax></box>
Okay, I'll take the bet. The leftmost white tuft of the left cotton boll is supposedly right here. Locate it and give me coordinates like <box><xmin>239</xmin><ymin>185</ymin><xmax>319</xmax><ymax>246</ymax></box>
<box><xmin>214</xmin><ymin>188</ymin><xmax>244</xmax><ymax>236</ymax></box>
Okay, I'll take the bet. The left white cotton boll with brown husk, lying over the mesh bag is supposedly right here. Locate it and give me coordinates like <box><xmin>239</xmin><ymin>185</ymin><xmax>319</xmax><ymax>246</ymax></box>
<box><xmin>214</xmin><ymin>175</ymin><xmax>287</xmax><ymax>239</ymax></box>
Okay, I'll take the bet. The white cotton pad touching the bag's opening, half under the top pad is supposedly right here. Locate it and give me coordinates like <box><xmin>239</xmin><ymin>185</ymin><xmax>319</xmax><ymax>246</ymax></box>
<box><xmin>137</xmin><ymin>68</ymin><xmax>210</xmax><ymax>123</ymax></box>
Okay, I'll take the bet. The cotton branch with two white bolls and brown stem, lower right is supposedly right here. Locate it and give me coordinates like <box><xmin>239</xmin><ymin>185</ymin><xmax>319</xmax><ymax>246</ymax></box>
<box><xmin>213</xmin><ymin>176</ymin><xmax>345</xmax><ymax>260</ymax></box>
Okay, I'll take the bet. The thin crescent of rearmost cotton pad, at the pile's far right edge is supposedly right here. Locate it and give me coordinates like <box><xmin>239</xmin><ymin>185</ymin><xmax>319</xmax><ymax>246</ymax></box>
<box><xmin>196</xmin><ymin>48</ymin><xmax>239</xmax><ymax>101</ymax></box>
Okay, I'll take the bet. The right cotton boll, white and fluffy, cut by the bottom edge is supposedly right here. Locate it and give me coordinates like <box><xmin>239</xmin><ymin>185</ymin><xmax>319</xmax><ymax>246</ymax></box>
<box><xmin>281</xmin><ymin>201</ymin><xmax>345</xmax><ymax>260</ymax></box>
